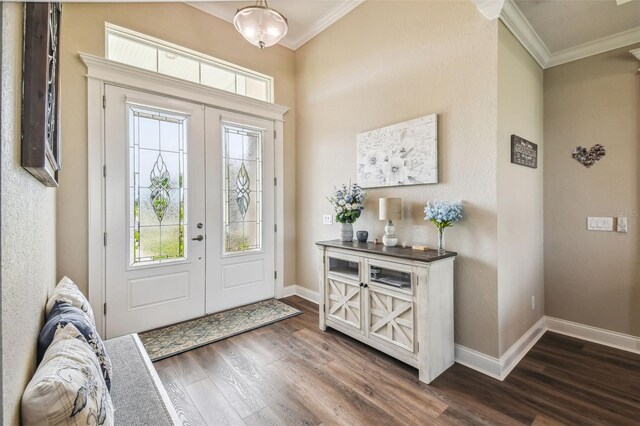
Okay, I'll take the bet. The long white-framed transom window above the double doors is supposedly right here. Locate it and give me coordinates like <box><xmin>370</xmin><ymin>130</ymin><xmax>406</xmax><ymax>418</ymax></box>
<box><xmin>105</xmin><ymin>23</ymin><xmax>274</xmax><ymax>103</ymax></box>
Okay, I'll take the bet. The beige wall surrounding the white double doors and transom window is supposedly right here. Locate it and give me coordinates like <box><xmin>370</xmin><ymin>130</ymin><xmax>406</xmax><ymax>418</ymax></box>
<box><xmin>57</xmin><ymin>3</ymin><xmax>296</xmax><ymax>291</ymax></box>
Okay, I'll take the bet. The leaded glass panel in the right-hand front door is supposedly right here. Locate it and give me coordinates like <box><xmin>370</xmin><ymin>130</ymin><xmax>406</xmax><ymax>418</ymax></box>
<box><xmin>222</xmin><ymin>123</ymin><xmax>263</xmax><ymax>254</ymax></box>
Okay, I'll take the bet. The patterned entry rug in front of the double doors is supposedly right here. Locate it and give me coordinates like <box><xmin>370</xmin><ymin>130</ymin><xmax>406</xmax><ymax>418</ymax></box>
<box><xmin>140</xmin><ymin>299</ymin><xmax>302</xmax><ymax>361</ymax></box>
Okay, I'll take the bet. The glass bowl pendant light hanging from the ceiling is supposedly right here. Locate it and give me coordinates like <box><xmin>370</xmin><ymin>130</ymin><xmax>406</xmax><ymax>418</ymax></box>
<box><xmin>233</xmin><ymin>0</ymin><xmax>289</xmax><ymax>50</ymax></box>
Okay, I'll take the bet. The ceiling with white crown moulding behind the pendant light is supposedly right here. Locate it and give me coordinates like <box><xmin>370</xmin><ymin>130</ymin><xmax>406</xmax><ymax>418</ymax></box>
<box><xmin>189</xmin><ymin>0</ymin><xmax>364</xmax><ymax>50</ymax></box>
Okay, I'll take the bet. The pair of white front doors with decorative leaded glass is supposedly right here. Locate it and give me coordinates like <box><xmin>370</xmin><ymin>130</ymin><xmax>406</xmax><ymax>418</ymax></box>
<box><xmin>105</xmin><ymin>85</ymin><xmax>274</xmax><ymax>337</ymax></box>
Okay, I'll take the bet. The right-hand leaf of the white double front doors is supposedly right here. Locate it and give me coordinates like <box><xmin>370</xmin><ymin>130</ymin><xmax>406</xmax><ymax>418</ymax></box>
<box><xmin>205</xmin><ymin>108</ymin><xmax>275</xmax><ymax>313</ymax></box>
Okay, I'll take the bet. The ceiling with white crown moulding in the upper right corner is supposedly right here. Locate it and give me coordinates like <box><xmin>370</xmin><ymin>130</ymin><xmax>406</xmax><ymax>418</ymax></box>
<box><xmin>500</xmin><ymin>0</ymin><xmax>640</xmax><ymax>68</ymax></box>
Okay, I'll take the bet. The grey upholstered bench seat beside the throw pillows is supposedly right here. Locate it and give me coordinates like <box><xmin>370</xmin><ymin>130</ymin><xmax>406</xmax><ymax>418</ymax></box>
<box><xmin>104</xmin><ymin>334</ymin><xmax>180</xmax><ymax>426</ymax></box>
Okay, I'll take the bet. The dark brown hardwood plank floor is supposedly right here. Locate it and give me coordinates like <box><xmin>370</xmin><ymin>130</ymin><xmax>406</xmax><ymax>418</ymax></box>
<box><xmin>155</xmin><ymin>297</ymin><xmax>640</xmax><ymax>425</ymax></box>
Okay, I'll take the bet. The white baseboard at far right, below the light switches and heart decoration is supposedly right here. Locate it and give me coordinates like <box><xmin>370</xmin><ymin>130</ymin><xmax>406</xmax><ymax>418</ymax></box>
<box><xmin>546</xmin><ymin>316</ymin><xmax>640</xmax><ymax>354</ymax></box>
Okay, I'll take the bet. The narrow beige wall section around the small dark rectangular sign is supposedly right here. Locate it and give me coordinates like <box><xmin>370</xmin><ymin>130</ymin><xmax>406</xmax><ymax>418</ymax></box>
<box><xmin>498</xmin><ymin>23</ymin><xmax>544</xmax><ymax>355</ymax></box>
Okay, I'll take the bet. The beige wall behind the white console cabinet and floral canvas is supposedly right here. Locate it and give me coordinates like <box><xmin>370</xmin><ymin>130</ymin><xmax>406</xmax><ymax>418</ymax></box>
<box><xmin>295</xmin><ymin>1</ymin><xmax>498</xmax><ymax>356</ymax></box>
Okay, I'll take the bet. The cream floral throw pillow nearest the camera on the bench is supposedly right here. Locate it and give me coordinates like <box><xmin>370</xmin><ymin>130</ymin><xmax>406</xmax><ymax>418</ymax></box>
<box><xmin>21</xmin><ymin>324</ymin><xmax>113</xmax><ymax>426</ymax></box>
